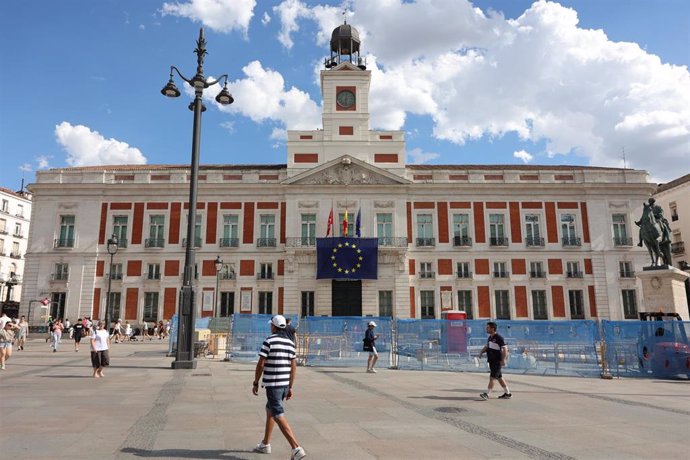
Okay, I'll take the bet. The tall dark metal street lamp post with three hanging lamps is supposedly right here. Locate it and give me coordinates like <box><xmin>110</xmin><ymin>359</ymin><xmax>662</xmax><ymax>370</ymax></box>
<box><xmin>161</xmin><ymin>28</ymin><xmax>234</xmax><ymax>369</ymax></box>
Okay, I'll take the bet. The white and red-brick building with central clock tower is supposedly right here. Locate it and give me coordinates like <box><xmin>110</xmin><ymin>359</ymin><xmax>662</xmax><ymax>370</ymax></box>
<box><xmin>22</xmin><ymin>24</ymin><xmax>656</xmax><ymax>323</ymax></box>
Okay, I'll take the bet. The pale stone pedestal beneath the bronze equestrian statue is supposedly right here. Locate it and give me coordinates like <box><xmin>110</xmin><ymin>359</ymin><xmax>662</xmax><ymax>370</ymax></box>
<box><xmin>637</xmin><ymin>265</ymin><xmax>690</xmax><ymax>321</ymax></box>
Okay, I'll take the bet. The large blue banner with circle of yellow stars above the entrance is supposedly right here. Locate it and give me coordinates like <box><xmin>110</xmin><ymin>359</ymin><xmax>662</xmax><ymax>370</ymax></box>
<box><xmin>316</xmin><ymin>237</ymin><xmax>379</xmax><ymax>280</ymax></box>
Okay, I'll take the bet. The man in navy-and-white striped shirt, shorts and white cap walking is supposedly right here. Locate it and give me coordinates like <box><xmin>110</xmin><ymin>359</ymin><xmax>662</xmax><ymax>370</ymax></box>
<box><xmin>252</xmin><ymin>315</ymin><xmax>307</xmax><ymax>460</ymax></box>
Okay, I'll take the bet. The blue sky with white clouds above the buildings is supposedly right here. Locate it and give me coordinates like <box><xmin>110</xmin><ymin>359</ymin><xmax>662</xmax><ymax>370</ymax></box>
<box><xmin>0</xmin><ymin>0</ymin><xmax>690</xmax><ymax>189</ymax></box>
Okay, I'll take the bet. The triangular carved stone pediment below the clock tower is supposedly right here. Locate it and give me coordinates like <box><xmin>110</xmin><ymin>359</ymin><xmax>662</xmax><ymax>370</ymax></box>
<box><xmin>283</xmin><ymin>155</ymin><xmax>411</xmax><ymax>185</ymax></box>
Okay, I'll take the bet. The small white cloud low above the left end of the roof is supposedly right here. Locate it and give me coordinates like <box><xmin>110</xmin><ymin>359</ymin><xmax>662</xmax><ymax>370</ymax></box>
<box><xmin>55</xmin><ymin>121</ymin><xmax>146</xmax><ymax>168</ymax></box>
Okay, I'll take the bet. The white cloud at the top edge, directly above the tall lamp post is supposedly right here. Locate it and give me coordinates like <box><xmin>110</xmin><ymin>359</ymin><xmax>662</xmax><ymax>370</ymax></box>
<box><xmin>161</xmin><ymin>0</ymin><xmax>256</xmax><ymax>36</ymax></box>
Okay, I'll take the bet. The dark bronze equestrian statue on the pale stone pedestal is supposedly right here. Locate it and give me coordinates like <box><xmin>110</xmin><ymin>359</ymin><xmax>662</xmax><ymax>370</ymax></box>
<box><xmin>635</xmin><ymin>198</ymin><xmax>673</xmax><ymax>267</ymax></box>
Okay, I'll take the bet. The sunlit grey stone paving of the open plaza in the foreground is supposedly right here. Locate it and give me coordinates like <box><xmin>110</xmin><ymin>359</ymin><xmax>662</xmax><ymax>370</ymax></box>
<box><xmin>0</xmin><ymin>339</ymin><xmax>690</xmax><ymax>460</ymax></box>
